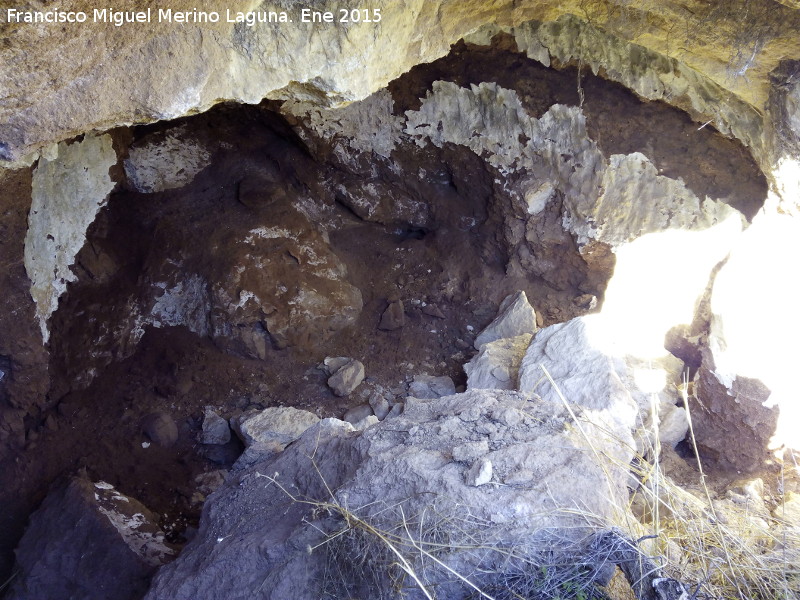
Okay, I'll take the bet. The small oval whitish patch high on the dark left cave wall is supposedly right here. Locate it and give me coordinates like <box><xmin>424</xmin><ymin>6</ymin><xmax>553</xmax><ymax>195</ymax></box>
<box><xmin>124</xmin><ymin>127</ymin><xmax>211</xmax><ymax>194</ymax></box>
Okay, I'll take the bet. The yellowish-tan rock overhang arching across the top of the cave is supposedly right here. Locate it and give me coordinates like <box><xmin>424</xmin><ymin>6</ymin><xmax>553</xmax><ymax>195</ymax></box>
<box><xmin>0</xmin><ymin>0</ymin><xmax>800</xmax><ymax>171</ymax></box>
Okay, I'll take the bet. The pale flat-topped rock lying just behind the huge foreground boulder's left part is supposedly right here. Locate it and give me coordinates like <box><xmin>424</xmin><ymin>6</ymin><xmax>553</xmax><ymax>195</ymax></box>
<box><xmin>231</xmin><ymin>406</ymin><xmax>319</xmax><ymax>447</ymax></box>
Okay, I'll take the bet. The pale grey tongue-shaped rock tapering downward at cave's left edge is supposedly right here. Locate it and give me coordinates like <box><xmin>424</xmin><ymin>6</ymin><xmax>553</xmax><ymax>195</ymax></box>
<box><xmin>25</xmin><ymin>135</ymin><xmax>117</xmax><ymax>343</ymax></box>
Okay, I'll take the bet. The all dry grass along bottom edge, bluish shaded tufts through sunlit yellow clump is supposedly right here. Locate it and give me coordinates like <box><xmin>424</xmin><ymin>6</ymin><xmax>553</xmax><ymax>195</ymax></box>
<box><xmin>261</xmin><ymin>371</ymin><xmax>800</xmax><ymax>600</ymax></box>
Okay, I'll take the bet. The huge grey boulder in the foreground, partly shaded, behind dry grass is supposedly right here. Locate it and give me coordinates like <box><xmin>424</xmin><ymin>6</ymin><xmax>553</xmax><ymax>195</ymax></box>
<box><xmin>146</xmin><ymin>391</ymin><xmax>631</xmax><ymax>600</ymax></box>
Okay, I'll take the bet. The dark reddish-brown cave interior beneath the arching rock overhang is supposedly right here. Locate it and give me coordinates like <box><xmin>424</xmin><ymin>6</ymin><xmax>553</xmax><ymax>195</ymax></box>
<box><xmin>0</xmin><ymin>36</ymin><xmax>766</xmax><ymax>584</ymax></box>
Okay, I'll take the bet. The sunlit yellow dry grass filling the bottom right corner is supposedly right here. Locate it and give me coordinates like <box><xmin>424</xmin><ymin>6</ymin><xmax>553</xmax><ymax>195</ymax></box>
<box><xmin>620</xmin><ymin>385</ymin><xmax>800</xmax><ymax>600</ymax></box>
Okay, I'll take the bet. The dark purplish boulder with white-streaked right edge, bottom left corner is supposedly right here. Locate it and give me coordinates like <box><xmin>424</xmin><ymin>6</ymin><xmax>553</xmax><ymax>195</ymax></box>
<box><xmin>6</xmin><ymin>478</ymin><xmax>176</xmax><ymax>600</ymax></box>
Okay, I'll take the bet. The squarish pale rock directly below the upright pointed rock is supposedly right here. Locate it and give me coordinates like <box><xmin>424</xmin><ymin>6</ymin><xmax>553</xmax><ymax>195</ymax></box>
<box><xmin>464</xmin><ymin>333</ymin><xmax>533</xmax><ymax>390</ymax></box>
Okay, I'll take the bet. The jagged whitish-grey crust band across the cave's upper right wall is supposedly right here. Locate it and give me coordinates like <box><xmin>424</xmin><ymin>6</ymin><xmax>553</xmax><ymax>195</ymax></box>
<box><xmin>405</xmin><ymin>81</ymin><xmax>736</xmax><ymax>247</ymax></box>
